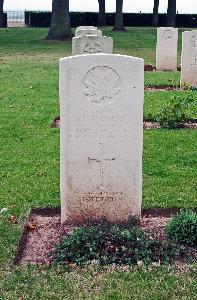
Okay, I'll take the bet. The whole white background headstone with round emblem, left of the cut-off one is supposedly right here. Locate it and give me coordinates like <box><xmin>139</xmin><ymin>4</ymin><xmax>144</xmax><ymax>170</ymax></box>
<box><xmin>156</xmin><ymin>27</ymin><xmax>178</xmax><ymax>71</ymax></box>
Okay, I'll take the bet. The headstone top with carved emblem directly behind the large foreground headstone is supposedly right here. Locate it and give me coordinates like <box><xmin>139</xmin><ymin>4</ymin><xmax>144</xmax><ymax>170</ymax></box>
<box><xmin>72</xmin><ymin>35</ymin><xmax>113</xmax><ymax>55</ymax></box>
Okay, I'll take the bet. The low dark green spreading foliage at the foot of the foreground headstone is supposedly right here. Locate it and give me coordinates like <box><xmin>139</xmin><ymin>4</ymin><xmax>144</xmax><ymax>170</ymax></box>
<box><xmin>52</xmin><ymin>220</ymin><xmax>180</xmax><ymax>266</ymax></box>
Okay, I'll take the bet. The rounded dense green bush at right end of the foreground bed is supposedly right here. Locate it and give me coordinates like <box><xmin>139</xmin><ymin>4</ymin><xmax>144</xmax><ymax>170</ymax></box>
<box><xmin>166</xmin><ymin>210</ymin><xmax>197</xmax><ymax>246</ymax></box>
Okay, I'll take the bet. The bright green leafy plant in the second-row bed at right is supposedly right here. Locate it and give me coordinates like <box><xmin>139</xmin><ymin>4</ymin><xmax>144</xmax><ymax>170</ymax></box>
<box><xmin>156</xmin><ymin>95</ymin><xmax>195</xmax><ymax>128</ymax></box>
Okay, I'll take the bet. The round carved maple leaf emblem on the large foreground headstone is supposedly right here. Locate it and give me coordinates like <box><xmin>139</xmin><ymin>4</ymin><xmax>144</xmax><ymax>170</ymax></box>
<box><xmin>83</xmin><ymin>66</ymin><xmax>121</xmax><ymax>106</ymax></box>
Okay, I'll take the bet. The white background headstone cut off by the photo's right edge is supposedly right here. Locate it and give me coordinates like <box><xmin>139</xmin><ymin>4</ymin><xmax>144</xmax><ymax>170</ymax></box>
<box><xmin>181</xmin><ymin>30</ymin><xmax>197</xmax><ymax>87</ymax></box>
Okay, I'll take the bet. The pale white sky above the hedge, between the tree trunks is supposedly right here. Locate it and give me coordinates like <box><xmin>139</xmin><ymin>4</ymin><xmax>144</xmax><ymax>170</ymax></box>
<box><xmin>4</xmin><ymin>0</ymin><xmax>197</xmax><ymax>13</ymax></box>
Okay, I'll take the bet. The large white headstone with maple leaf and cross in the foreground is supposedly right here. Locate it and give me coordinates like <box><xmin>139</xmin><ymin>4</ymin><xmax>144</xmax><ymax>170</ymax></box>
<box><xmin>60</xmin><ymin>54</ymin><xmax>144</xmax><ymax>223</ymax></box>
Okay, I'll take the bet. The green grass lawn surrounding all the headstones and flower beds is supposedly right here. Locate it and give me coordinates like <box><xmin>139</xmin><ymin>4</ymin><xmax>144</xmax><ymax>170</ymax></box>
<box><xmin>0</xmin><ymin>28</ymin><xmax>197</xmax><ymax>300</ymax></box>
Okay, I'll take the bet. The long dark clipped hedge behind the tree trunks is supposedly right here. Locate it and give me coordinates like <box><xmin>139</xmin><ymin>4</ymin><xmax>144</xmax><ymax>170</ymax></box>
<box><xmin>25</xmin><ymin>11</ymin><xmax>197</xmax><ymax>28</ymax></box>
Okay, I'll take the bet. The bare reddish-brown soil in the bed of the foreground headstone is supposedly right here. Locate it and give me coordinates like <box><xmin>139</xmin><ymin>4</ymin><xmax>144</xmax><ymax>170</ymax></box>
<box><xmin>14</xmin><ymin>208</ymin><xmax>194</xmax><ymax>265</ymax></box>
